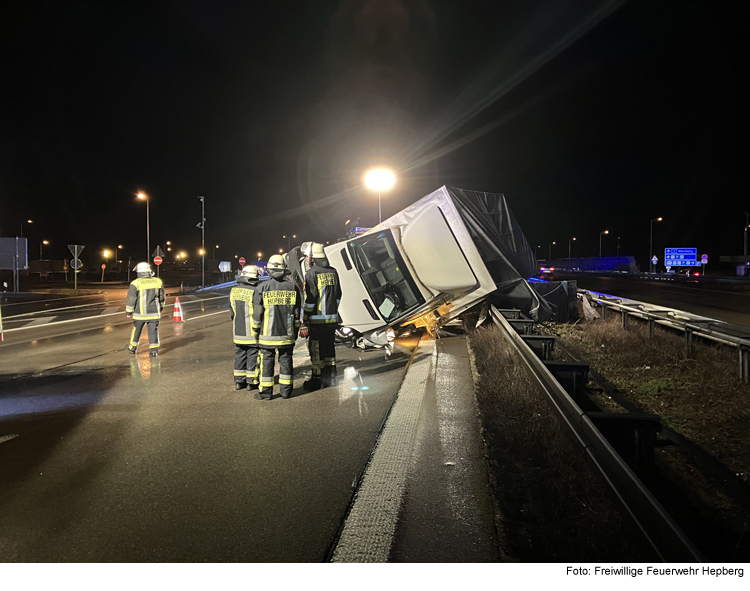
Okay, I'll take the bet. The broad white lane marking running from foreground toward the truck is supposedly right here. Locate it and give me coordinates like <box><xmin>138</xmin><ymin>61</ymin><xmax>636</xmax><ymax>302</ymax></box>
<box><xmin>332</xmin><ymin>341</ymin><xmax>435</xmax><ymax>563</ymax></box>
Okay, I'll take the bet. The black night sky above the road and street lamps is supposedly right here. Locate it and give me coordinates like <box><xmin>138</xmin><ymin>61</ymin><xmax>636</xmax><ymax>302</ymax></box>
<box><xmin>0</xmin><ymin>0</ymin><xmax>750</xmax><ymax>268</ymax></box>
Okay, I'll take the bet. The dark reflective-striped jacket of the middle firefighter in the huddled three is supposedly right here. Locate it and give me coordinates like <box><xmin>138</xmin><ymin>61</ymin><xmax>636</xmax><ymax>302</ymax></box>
<box><xmin>253</xmin><ymin>271</ymin><xmax>302</xmax><ymax>349</ymax></box>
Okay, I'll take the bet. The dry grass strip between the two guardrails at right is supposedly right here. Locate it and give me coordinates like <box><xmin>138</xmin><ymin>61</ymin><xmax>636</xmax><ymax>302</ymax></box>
<box><xmin>548</xmin><ymin>318</ymin><xmax>750</xmax><ymax>482</ymax></box>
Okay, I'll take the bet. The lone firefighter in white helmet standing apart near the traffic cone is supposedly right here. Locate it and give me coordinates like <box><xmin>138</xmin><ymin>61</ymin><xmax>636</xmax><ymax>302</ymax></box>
<box><xmin>125</xmin><ymin>263</ymin><xmax>165</xmax><ymax>357</ymax></box>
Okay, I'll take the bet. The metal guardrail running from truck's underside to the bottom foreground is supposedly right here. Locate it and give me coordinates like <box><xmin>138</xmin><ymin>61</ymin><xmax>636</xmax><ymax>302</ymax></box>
<box><xmin>488</xmin><ymin>306</ymin><xmax>705</xmax><ymax>562</ymax></box>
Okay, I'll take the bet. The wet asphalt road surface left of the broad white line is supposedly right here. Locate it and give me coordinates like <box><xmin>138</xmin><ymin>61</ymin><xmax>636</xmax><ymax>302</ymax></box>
<box><xmin>0</xmin><ymin>292</ymin><xmax>416</xmax><ymax>562</ymax></box>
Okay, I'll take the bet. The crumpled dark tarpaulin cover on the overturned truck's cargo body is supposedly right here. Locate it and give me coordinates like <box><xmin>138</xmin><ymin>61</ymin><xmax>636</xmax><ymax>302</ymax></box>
<box><xmin>445</xmin><ymin>186</ymin><xmax>552</xmax><ymax>322</ymax></box>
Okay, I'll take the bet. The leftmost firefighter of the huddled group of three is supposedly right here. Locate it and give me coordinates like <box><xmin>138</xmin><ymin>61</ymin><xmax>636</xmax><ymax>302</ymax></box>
<box><xmin>229</xmin><ymin>265</ymin><xmax>260</xmax><ymax>390</ymax></box>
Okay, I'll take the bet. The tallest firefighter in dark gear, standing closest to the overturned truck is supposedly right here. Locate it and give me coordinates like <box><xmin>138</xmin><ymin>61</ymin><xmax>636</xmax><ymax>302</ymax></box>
<box><xmin>301</xmin><ymin>242</ymin><xmax>341</xmax><ymax>390</ymax></box>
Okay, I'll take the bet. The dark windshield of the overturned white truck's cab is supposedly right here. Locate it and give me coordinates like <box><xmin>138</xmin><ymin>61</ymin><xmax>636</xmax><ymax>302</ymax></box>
<box><xmin>349</xmin><ymin>230</ymin><xmax>424</xmax><ymax>322</ymax></box>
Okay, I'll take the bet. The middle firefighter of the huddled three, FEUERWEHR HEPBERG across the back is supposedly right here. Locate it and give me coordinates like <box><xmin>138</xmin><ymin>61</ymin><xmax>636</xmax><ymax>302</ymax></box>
<box><xmin>253</xmin><ymin>254</ymin><xmax>302</xmax><ymax>400</ymax></box>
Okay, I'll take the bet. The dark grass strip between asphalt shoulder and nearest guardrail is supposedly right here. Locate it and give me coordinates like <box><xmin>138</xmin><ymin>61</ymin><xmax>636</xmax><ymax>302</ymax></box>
<box><xmin>470</xmin><ymin>327</ymin><xmax>655</xmax><ymax>562</ymax></box>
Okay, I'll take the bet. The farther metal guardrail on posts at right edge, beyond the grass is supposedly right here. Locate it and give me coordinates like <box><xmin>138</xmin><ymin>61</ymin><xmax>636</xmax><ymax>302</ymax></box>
<box><xmin>578</xmin><ymin>289</ymin><xmax>750</xmax><ymax>384</ymax></box>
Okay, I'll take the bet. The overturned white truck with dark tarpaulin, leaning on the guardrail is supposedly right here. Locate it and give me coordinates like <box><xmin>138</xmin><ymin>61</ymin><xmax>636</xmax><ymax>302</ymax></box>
<box><xmin>325</xmin><ymin>186</ymin><xmax>551</xmax><ymax>345</ymax></box>
